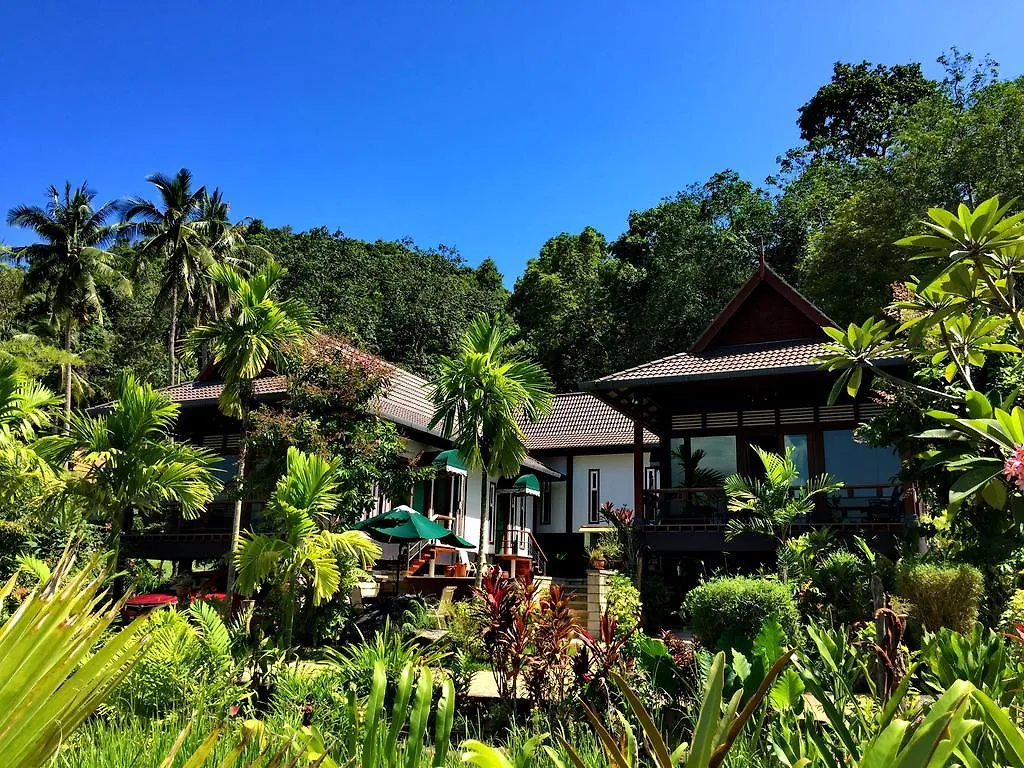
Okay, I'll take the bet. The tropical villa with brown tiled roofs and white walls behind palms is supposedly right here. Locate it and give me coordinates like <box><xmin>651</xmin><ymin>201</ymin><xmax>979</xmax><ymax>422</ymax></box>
<box><xmin>124</xmin><ymin>263</ymin><xmax>916</xmax><ymax>584</ymax></box>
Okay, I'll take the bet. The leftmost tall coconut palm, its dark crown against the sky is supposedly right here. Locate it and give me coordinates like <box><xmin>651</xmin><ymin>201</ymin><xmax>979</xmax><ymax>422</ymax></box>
<box><xmin>7</xmin><ymin>182</ymin><xmax>130</xmax><ymax>419</ymax></box>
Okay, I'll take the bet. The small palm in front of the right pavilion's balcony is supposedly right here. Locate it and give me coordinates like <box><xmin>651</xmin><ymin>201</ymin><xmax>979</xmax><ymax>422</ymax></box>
<box><xmin>725</xmin><ymin>445</ymin><xmax>843</xmax><ymax>580</ymax></box>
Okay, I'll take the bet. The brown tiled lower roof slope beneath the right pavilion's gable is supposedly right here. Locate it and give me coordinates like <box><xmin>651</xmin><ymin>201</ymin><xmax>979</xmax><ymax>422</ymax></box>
<box><xmin>594</xmin><ymin>339</ymin><xmax>826</xmax><ymax>387</ymax></box>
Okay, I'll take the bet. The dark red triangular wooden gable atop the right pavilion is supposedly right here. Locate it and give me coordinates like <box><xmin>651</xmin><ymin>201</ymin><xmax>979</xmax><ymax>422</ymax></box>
<box><xmin>690</xmin><ymin>265</ymin><xmax>833</xmax><ymax>354</ymax></box>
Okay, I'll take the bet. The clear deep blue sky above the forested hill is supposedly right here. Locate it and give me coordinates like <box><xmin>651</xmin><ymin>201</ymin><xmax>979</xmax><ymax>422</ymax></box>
<box><xmin>0</xmin><ymin>0</ymin><xmax>1024</xmax><ymax>285</ymax></box>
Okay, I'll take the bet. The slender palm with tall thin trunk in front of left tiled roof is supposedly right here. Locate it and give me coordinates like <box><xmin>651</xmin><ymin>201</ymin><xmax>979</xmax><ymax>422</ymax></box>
<box><xmin>185</xmin><ymin>259</ymin><xmax>317</xmax><ymax>594</ymax></box>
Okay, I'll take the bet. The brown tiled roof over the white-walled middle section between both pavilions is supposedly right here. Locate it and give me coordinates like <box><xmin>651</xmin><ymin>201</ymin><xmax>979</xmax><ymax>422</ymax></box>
<box><xmin>523</xmin><ymin>392</ymin><xmax>657</xmax><ymax>451</ymax></box>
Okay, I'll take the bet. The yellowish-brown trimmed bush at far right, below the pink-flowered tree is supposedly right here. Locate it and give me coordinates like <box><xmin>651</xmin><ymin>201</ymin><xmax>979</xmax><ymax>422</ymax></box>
<box><xmin>897</xmin><ymin>560</ymin><xmax>984</xmax><ymax>633</ymax></box>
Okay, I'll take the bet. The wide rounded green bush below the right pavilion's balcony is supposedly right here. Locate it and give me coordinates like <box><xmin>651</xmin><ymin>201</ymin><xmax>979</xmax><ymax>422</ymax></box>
<box><xmin>683</xmin><ymin>577</ymin><xmax>800</xmax><ymax>649</ymax></box>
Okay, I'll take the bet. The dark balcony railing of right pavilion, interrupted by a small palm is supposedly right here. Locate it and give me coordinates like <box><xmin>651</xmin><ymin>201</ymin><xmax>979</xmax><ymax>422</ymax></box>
<box><xmin>643</xmin><ymin>484</ymin><xmax>912</xmax><ymax>529</ymax></box>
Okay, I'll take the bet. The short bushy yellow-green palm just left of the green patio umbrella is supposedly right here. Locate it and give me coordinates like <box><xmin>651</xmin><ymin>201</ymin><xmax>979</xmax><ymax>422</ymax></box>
<box><xmin>234</xmin><ymin>446</ymin><xmax>381</xmax><ymax>648</ymax></box>
